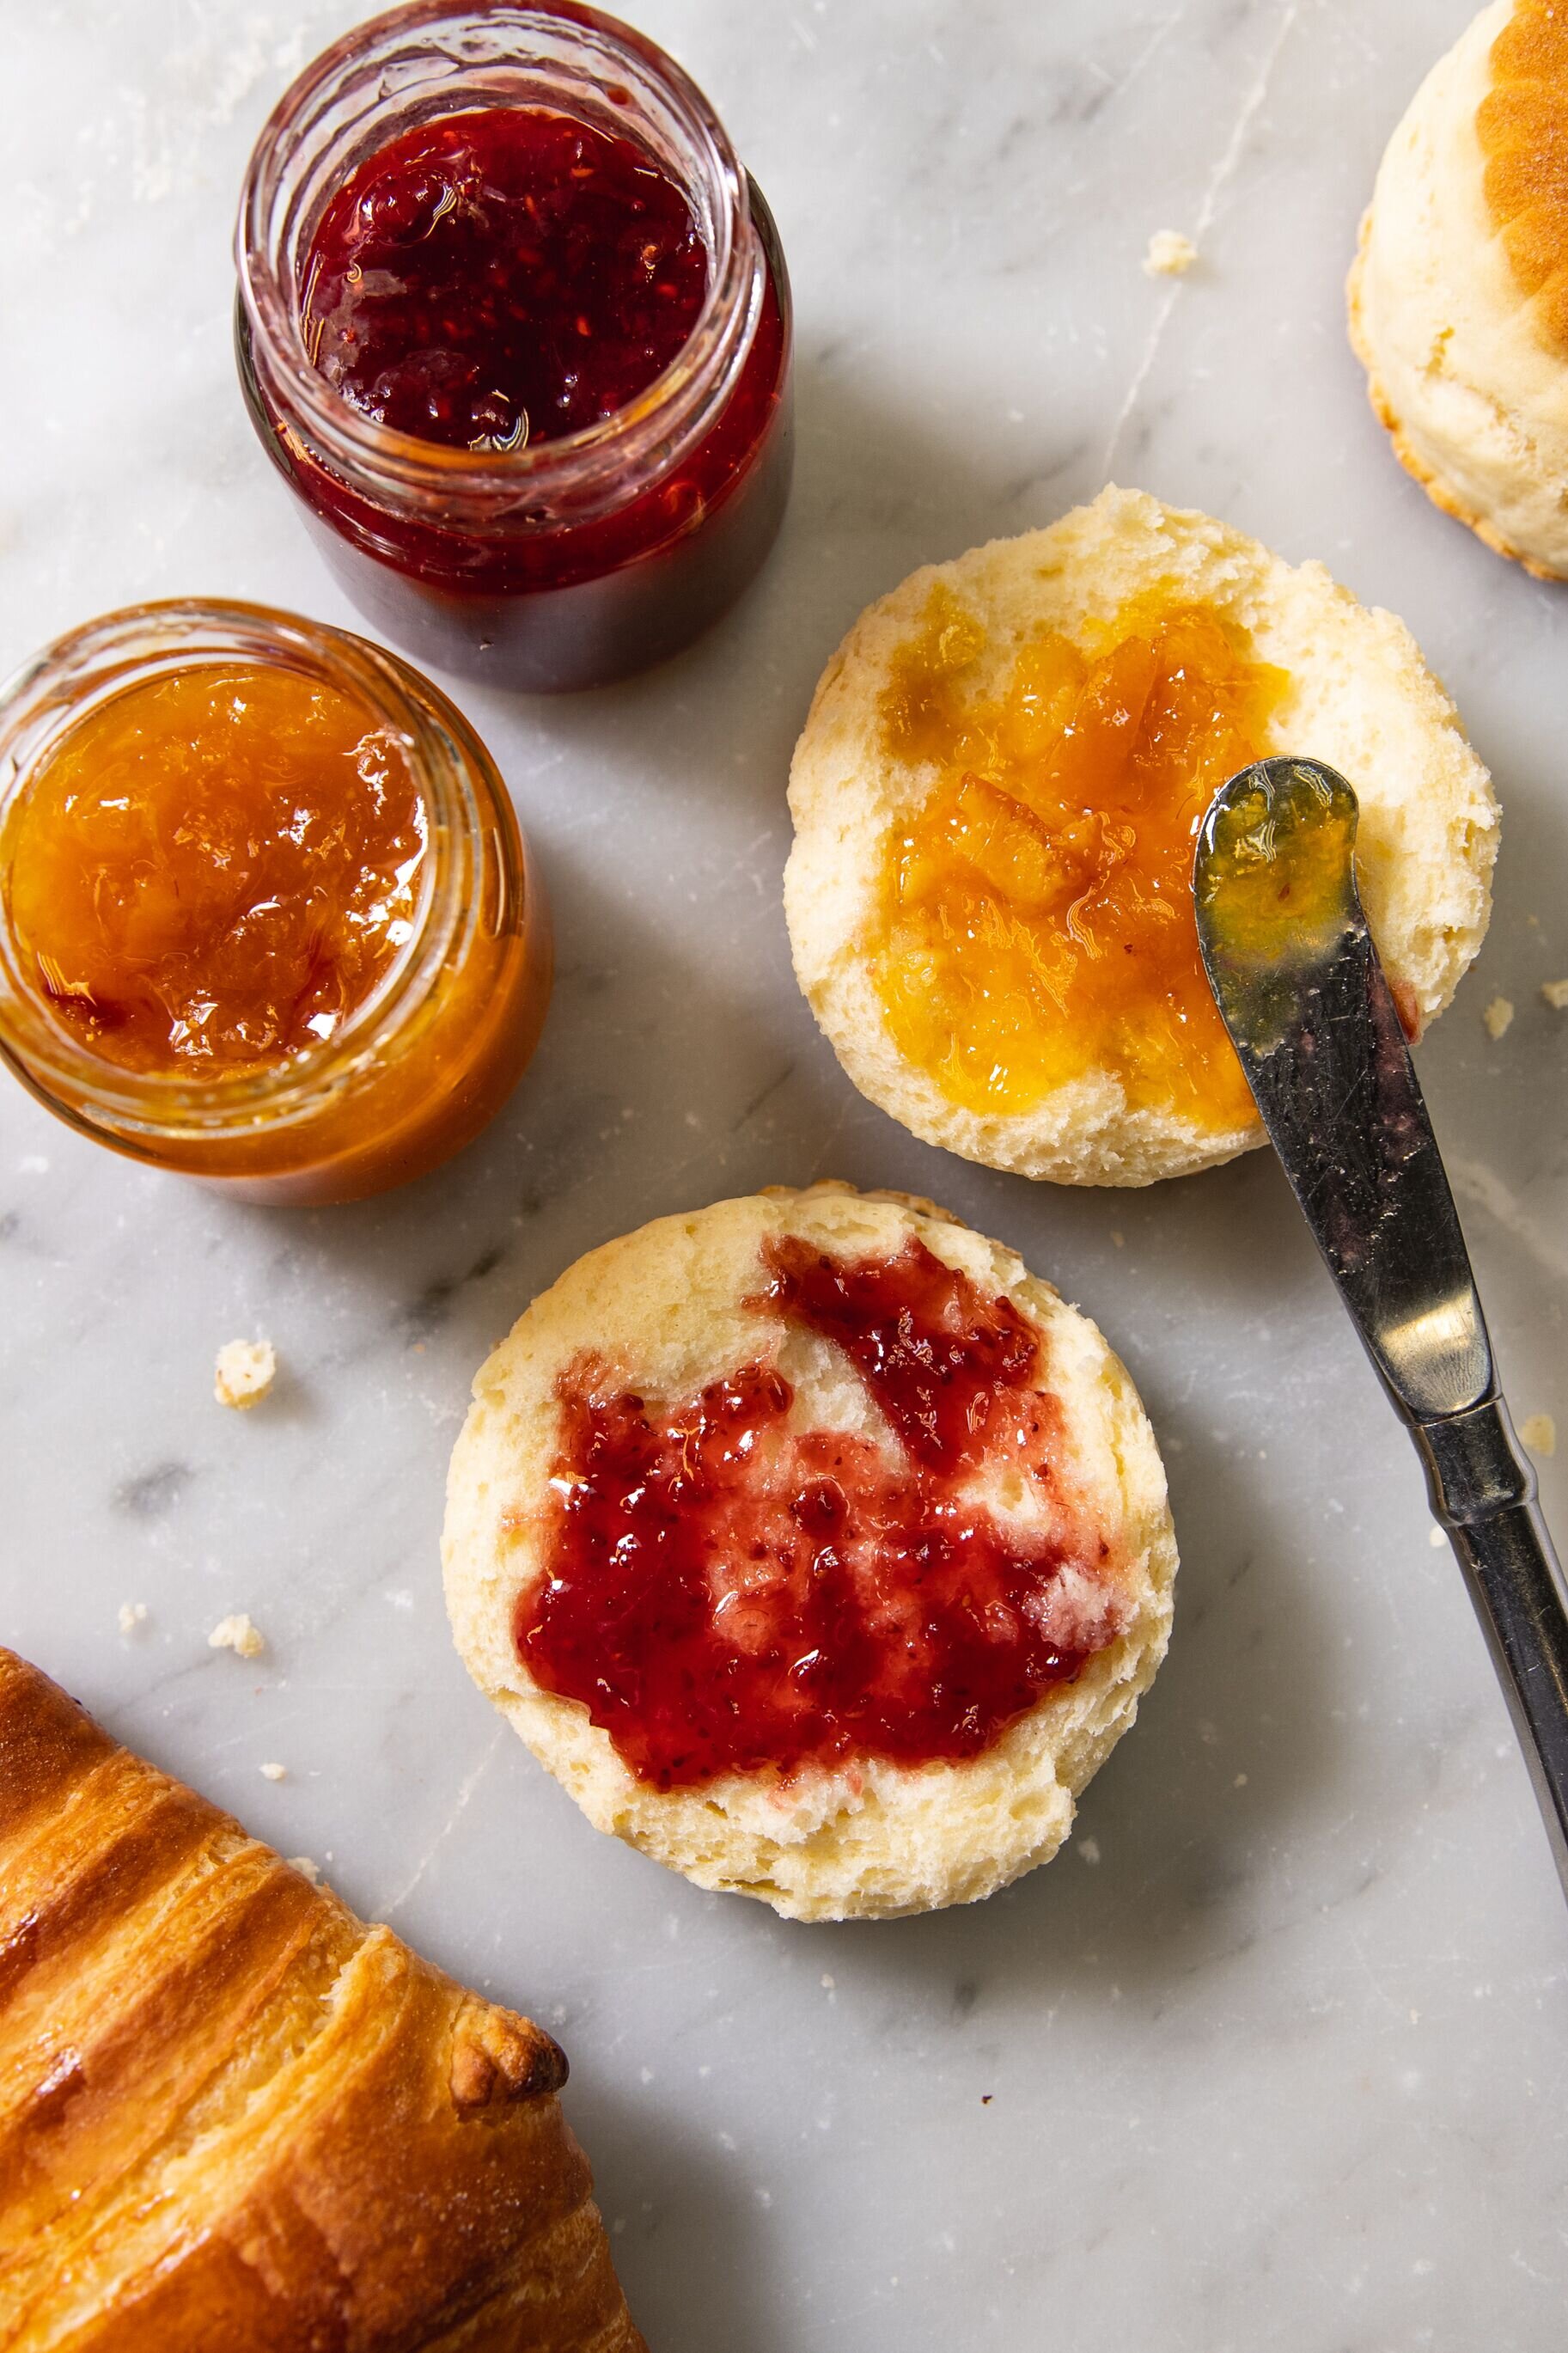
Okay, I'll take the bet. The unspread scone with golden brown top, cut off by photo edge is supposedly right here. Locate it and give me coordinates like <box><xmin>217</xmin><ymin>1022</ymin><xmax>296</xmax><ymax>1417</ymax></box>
<box><xmin>1350</xmin><ymin>0</ymin><xmax>1568</xmax><ymax>579</ymax></box>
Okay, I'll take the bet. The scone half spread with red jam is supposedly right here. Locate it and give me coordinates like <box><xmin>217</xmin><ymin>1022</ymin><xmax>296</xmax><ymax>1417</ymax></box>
<box><xmin>444</xmin><ymin>1183</ymin><xmax>1175</xmax><ymax>1920</ymax></box>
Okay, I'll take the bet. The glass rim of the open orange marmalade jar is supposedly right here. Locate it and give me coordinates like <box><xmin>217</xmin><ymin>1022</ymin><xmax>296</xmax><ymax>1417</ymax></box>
<box><xmin>0</xmin><ymin>597</ymin><xmax>486</xmax><ymax>1141</ymax></box>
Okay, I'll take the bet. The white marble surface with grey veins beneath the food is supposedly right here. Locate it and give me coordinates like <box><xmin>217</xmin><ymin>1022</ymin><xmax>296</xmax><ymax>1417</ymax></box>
<box><xmin>0</xmin><ymin>0</ymin><xmax>1568</xmax><ymax>2353</ymax></box>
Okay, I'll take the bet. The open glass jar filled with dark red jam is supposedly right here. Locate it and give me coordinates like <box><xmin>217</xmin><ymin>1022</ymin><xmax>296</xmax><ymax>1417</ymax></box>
<box><xmin>237</xmin><ymin>0</ymin><xmax>792</xmax><ymax>692</ymax></box>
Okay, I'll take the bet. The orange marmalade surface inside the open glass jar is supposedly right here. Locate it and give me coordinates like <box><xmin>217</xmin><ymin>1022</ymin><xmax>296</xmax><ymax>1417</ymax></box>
<box><xmin>0</xmin><ymin>663</ymin><xmax>425</xmax><ymax>1080</ymax></box>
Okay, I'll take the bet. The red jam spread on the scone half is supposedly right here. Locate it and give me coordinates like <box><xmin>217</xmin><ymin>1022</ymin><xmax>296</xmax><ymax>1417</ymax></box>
<box><xmin>515</xmin><ymin>1238</ymin><xmax>1117</xmax><ymax>1788</ymax></box>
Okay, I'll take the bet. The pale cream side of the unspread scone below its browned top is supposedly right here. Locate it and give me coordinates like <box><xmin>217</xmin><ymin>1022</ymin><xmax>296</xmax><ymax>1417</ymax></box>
<box><xmin>1350</xmin><ymin>0</ymin><xmax>1568</xmax><ymax>577</ymax></box>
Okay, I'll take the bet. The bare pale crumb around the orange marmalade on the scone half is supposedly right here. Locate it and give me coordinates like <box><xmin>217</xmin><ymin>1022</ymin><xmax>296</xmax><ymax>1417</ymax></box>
<box><xmin>785</xmin><ymin>487</ymin><xmax>1498</xmax><ymax>1183</ymax></box>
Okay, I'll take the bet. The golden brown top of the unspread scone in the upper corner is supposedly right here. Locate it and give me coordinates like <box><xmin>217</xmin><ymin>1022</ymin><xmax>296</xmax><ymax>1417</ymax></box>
<box><xmin>1476</xmin><ymin>0</ymin><xmax>1568</xmax><ymax>351</ymax></box>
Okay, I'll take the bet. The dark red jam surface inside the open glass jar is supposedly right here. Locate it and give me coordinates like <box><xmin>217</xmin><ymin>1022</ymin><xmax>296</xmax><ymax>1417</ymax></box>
<box><xmin>303</xmin><ymin>106</ymin><xmax>708</xmax><ymax>449</ymax></box>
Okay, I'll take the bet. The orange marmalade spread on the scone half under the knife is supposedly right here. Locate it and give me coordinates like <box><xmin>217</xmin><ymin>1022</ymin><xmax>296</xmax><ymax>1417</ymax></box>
<box><xmin>875</xmin><ymin>586</ymin><xmax>1284</xmax><ymax>1129</ymax></box>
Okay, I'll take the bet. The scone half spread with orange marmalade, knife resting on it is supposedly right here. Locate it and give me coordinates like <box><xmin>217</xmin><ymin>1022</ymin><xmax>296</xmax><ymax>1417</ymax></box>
<box><xmin>785</xmin><ymin>490</ymin><xmax>1498</xmax><ymax>1186</ymax></box>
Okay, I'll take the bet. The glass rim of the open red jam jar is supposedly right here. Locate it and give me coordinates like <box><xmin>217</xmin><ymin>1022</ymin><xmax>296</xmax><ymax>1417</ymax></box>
<box><xmin>235</xmin><ymin>0</ymin><xmax>766</xmax><ymax>525</ymax></box>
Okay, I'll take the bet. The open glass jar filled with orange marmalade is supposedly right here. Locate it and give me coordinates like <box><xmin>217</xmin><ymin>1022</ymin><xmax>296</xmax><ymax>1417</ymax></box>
<box><xmin>0</xmin><ymin>602</ymin><xmax>550</xmax><ymax>1202</ymax></box>
